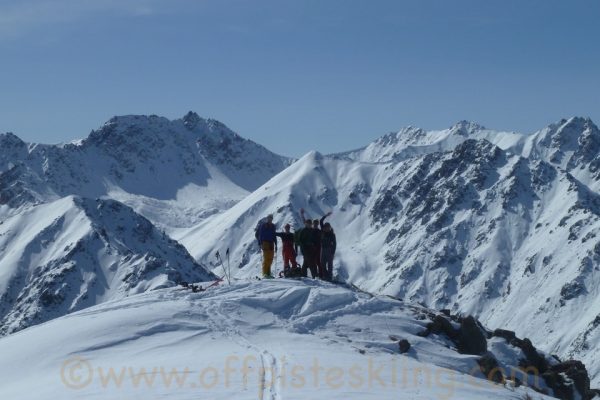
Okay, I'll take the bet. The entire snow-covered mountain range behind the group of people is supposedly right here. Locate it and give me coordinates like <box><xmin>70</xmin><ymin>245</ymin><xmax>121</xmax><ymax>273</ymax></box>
<box><xmin>0</xmin><ymin>113</ymin><xmax>600</xmax><ymax>394</ymax></box>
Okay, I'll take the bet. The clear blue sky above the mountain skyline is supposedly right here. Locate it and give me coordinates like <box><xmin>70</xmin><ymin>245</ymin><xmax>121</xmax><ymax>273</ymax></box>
<box><xmin>0</xmin><ymin>0</ymin><xmax>600</xmax><ymax>156</ymax></box>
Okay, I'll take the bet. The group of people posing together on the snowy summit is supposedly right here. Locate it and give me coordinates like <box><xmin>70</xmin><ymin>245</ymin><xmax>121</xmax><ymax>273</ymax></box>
<box><xmin>256</xmin><ymin>209</ymin><xmax>337</xmax><ymax>281</ymax></box>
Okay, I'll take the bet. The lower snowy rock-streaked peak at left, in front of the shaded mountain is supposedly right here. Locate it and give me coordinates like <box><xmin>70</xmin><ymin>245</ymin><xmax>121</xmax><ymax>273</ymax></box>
<box><xmin>0</xmin><ymin>196</ymin><xmax>212</xmax><ymax>334</ymax></box>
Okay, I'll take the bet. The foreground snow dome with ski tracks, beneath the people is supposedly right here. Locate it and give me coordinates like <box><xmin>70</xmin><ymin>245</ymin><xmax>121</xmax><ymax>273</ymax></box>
<box><xmin>0</xmin><ymin>280</ymin><xmax>578</xmax><ymax>400</ymax></box>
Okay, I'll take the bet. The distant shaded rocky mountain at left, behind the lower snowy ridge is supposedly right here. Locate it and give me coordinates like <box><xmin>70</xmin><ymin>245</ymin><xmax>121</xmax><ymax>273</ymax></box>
<box><xmin>0</xmin><ymin>112</ymin><xmax>292</xmax><ymax>231</ymax></box>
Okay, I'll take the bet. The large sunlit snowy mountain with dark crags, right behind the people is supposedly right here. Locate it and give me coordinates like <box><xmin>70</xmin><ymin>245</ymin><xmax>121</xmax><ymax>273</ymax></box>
<box><xmin>175</xmin><ymin>118</ymin><xmax>600</xmax><ymax>384</ymax></box>
